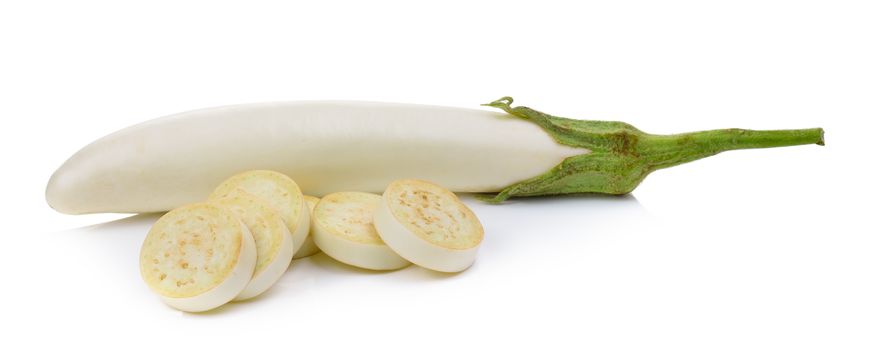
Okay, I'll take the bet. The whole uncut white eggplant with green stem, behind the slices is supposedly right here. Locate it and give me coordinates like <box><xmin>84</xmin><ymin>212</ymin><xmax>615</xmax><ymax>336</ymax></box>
<box><xmin>46</xmin><ymin>97</ymin><xmax>823</xmax><ymax>214</ymax></box>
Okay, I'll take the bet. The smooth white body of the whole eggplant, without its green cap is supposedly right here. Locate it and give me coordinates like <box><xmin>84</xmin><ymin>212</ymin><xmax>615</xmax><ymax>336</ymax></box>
<box><xmin>46</xmin><ymin>101</ymin><xmax>588</xmax><ymax>214</ymax></box>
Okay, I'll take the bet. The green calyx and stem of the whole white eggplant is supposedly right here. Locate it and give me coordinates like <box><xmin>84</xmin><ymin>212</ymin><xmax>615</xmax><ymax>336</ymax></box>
<box><xmin>479</xmin><ymin>97</ymin><xmax>825</xmax><ymax>203</ymax></box>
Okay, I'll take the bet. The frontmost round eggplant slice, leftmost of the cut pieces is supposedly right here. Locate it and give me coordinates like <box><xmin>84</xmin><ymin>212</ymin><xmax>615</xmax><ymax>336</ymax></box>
<box><xmin>140</xmin><ymin>203</ymin><xmax>257</xmax><ymax>312</ymax></box>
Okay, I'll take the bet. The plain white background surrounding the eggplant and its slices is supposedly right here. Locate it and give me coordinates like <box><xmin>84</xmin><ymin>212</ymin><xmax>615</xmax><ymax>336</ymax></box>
<box><xmin>0</xmin><ymin>0</ymin><xmax>870</xmax><ymax>349</ymax></box>
